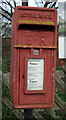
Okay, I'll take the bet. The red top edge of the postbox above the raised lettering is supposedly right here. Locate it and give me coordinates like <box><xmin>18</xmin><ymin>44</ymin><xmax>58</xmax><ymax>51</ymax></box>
<box><xmin>15</xmin><ymin>6</ymin><xmax>57</xmax><ymax>12</ymax></box>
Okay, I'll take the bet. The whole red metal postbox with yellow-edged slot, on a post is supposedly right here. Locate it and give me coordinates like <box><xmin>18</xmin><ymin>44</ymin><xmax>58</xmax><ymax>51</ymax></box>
<box><xmin>10</xmin><ymin>6</ymin><xmax>57</xmax><ymax>108</ymax></box>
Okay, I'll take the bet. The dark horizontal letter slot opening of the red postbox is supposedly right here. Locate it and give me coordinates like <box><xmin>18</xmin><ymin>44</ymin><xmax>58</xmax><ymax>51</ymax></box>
<box><xmin>18</xmin><ymin>24</ymin><xmax>55</xmax><ymax>31</ymax></box>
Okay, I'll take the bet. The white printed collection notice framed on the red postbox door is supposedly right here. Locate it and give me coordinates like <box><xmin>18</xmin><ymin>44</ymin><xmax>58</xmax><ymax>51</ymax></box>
<box><xmin>27</xmin><ymin>58</ymin><xmax>44</xmax><ymax>90</ymax></box>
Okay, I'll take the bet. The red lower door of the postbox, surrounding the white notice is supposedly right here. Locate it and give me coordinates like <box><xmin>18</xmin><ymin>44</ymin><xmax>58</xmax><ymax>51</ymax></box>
<box><xmin>16</xmin><ymin>49</ymin><xmax>54</xmax><ymax>107</ymax></box>
